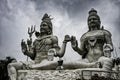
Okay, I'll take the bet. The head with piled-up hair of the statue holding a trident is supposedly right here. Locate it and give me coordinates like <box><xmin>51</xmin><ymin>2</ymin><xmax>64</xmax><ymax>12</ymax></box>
<box><xmin>40</xmin><ymin>14</ymin><xmax>52</xmax><ymax>35</ymax></box>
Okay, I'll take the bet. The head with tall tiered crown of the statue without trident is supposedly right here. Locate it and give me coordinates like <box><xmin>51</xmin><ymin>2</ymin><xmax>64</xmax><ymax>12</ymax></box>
<box><xmin>88</xmin><ymin>8</ymin><xmax>101</xmax><ymax>31</ymax></box>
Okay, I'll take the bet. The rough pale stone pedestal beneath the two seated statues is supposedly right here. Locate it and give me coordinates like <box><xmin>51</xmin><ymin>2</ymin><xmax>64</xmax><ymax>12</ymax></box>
<box><xmin>18</xmin><ymin>68</ymin><xmax>119</xmax><ymax>80</ymax></box>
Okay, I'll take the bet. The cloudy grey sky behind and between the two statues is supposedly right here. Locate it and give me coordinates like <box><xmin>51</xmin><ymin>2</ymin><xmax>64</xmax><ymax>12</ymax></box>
<box><xmin>0</xmin><ymin>0</ymin><xmax>120</xmax><ymax>60</ymax></box>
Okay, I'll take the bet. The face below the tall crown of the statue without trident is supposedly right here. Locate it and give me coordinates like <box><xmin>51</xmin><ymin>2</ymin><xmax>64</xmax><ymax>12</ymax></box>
<box><xmin>88</xmin><ymin>16</ymin><xmax>100</xmax><ymax>29</ymax></box>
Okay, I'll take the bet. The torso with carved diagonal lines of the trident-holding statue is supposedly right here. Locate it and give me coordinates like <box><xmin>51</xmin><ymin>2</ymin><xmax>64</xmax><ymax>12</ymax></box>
<box><xmin>34</xmin><ymin>36</ymin><xmax>57</xmax><ymax>62</ymax></box>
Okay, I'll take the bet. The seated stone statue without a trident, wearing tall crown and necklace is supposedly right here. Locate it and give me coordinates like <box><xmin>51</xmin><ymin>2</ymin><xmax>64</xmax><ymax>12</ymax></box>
<box><xmin>35</xmin><ymin>8</ymin><xmax>113</xmax><ymax>70</ymax></box>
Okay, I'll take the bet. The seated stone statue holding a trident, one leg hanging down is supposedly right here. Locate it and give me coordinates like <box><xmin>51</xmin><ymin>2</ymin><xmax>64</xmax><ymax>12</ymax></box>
<box><xmin>8</xmin><ymin>14</ymin><xmax>69</xmax><ymax>80</ymax></box>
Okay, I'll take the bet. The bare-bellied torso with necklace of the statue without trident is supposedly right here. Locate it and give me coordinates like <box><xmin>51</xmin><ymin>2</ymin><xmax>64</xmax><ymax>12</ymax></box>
<box><xmin>81</xmin><ymin>30</ymin><xmax>109</xmax><ymax>62</ymax></box>
